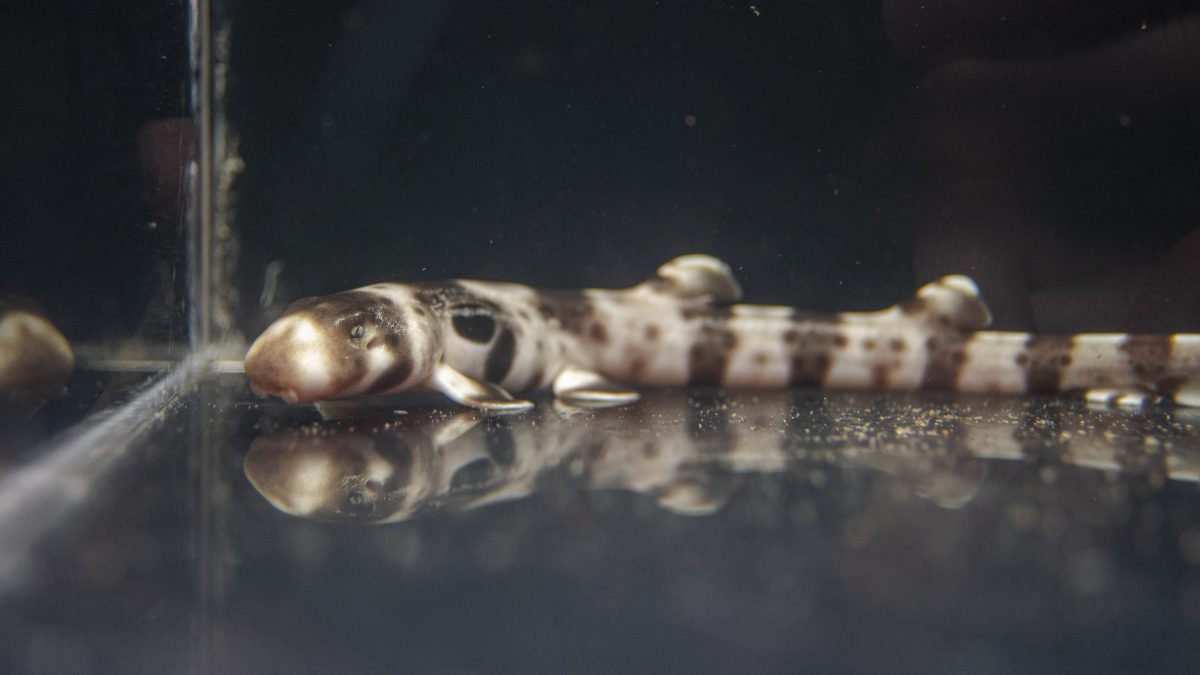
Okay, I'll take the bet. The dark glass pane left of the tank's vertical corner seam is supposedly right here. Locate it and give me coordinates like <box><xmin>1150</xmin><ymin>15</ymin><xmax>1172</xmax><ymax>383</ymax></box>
<box><xmin>0</xmin><ymin>0</ymin><xmax>192</xmax><ymax>342</ymax></box>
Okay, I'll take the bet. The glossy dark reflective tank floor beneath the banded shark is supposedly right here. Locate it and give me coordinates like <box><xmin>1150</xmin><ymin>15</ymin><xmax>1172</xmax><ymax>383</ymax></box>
<box><xmin>0</xmin><ymin>376</ymin><xmax>1200</xmax><ymax>673</ymax></box>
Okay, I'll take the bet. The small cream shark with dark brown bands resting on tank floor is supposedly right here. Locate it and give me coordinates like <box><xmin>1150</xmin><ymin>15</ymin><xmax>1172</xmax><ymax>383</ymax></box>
<box><xmin>246</xmin><ymin>255</ymin><xmax>1200</xmax><ymax>412</ymax></box>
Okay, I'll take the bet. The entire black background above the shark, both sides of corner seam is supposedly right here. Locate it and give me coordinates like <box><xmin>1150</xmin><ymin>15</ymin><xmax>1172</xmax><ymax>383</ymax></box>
<box><xmin>0</xmin><ymin>0</ymin><xmax>1200</xmax><ymax>341</ymax></box>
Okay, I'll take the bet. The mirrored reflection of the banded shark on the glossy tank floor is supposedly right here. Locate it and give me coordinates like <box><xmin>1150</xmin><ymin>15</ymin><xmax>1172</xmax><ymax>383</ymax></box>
<box><xmin>245</xmin><ymin>392</ymin><xmax>1200</xmax><ymax>522</ymax></box>
